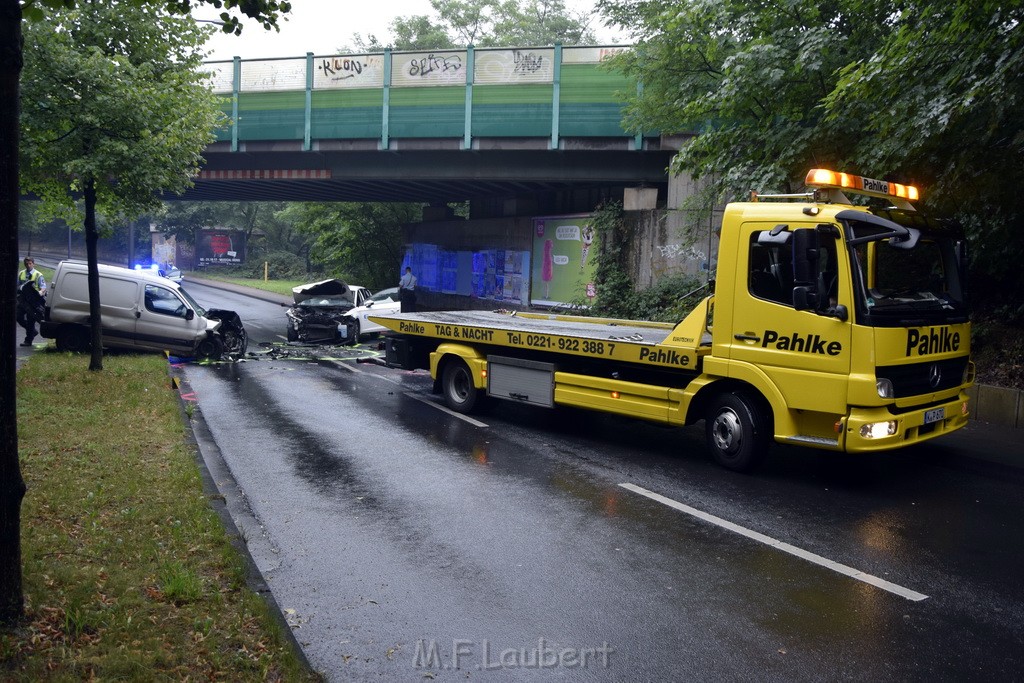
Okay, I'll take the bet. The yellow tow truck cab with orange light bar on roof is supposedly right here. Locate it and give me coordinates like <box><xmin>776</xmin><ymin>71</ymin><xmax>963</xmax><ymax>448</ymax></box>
<box><xmin>703</xmin><ymin>170</ymin><xmax>974</xmax><ymax>452</ymax></box>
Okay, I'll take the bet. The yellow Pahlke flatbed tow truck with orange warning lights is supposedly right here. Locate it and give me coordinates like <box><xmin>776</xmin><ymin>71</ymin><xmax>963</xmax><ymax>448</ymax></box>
<box><xmin>372</xmin><ymin>169</ymin><xmax>974</xmax><ymax>471</ymax></box>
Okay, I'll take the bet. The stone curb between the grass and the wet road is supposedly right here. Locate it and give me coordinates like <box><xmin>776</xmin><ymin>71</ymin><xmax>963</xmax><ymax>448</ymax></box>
<box><xmin>168</xmin><ymin>364</ymin><xmax>318</xmax><ymax>675</ymax></box>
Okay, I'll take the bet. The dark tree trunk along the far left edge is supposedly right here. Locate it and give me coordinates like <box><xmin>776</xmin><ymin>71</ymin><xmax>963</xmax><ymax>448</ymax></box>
<box><xmin>0</xmin><ymin>0</ymin><xmax>25</xmax><ymax>624</ymax></box>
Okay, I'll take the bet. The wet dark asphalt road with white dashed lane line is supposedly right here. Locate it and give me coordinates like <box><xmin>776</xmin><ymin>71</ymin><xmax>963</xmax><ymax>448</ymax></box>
<box><xmin>182</xmin><ymin>285</ymin><xmax>1024</xmax><ymax>681</ymax></box>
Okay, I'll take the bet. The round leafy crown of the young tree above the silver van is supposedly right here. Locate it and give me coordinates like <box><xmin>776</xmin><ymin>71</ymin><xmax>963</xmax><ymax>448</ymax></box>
<box><xmin>20</xmin><ymin>2</ymin><xmax>222</xmax><ymax>224</ymax></box>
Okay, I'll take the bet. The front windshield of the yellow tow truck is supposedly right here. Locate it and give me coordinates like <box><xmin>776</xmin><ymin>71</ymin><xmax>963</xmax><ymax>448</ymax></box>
<box><xmin>851</xmin><ymin>223</ymin><xmax>967</xmax><ymax>327</ymax></box>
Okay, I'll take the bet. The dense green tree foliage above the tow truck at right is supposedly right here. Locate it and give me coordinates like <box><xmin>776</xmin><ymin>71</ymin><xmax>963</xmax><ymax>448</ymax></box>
<box><xmin>599</xmin><ymin>0</ymin><xmax>1024</xmax><ymax>315</ymax></box>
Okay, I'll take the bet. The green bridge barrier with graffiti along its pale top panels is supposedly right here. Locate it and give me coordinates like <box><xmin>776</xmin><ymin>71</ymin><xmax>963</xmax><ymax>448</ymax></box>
<box><xmin>206</xmin><ymin>45</ymin><xmax>642</xmax><ymax>152</ymax></box>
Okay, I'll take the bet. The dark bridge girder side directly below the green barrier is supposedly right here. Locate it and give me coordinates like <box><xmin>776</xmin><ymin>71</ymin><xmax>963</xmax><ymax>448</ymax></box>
<box><xmin>172</xmin><ymin>139</ymin><xmax>676</xmax><ymax>203</ymax></box>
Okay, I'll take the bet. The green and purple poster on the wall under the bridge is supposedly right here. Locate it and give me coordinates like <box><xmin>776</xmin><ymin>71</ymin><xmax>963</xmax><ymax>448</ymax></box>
<box><xmin>530</xmin><ymin>215</ymin><xmax>597</xmax><ymax>306</ymax></box>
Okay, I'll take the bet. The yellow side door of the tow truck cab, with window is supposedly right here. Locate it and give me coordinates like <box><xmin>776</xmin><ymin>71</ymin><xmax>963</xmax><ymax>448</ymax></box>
<box><xmin>730</xmin><ymin>224</ymin><xmax>852</xmax><ymax>416</ymax></box>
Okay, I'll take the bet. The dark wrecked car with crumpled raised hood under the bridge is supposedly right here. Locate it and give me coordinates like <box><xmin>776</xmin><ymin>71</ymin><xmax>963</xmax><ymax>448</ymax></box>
<box><xmin>285</xmin><ymin>280</ymin><xmax>370</xmax><ymax>344</ymax></box>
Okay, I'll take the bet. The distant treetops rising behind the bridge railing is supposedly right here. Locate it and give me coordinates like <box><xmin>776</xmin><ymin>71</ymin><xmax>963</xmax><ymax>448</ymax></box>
<box><xmin>354</xmin><ymin>0</ymin><xmax>595</xmax><ymax>50</ymax></box>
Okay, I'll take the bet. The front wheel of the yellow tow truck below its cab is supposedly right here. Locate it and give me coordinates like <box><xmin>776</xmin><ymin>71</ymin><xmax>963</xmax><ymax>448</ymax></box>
<box><xmin>705</xmin><ymin>391</ymin><xmax>769</xmax><ymax>472</ymax></box>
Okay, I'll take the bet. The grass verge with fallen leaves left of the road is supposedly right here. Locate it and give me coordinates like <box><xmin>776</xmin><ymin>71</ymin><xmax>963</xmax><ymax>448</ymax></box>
<box><xmin>0</xmin><ymin>350</ymin><xmax>319</xmax><ymax>681</ymax></box>
